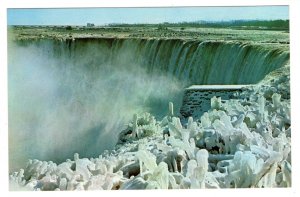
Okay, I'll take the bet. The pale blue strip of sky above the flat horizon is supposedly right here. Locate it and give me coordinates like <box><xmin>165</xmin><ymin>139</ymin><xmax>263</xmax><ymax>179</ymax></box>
<box><xmin>7</xmin><ymin>6</ymin><xmax>289</xmax><ymax>25</ymax></box>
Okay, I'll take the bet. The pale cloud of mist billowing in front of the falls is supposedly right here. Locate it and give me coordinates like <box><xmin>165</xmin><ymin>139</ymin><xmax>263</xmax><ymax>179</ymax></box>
<box><xmin>8</xmin><ymin>39</ymin><xmax>186</xmax><ymax>171</ymax></box>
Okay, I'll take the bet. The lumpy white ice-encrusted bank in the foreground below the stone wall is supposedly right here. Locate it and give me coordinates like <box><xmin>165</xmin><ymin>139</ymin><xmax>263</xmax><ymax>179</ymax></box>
<box><xmin>9</xmin><ymin>66</ymin><xmax>291</xmax><ymax>191</ymax></box>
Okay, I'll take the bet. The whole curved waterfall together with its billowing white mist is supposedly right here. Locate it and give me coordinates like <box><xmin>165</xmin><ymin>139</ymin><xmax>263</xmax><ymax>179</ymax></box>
<box><xmin>8</xmin><ymin>38</ymin><xmax>289</xmax><ymax>170</ymax></box>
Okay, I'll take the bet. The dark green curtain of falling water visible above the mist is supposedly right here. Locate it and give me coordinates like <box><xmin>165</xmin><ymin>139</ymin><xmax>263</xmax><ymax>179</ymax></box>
<box><xmin>19</xmin><ymin>38</ymin><xmax>289</xmax><ymax>84</ymax></box>
